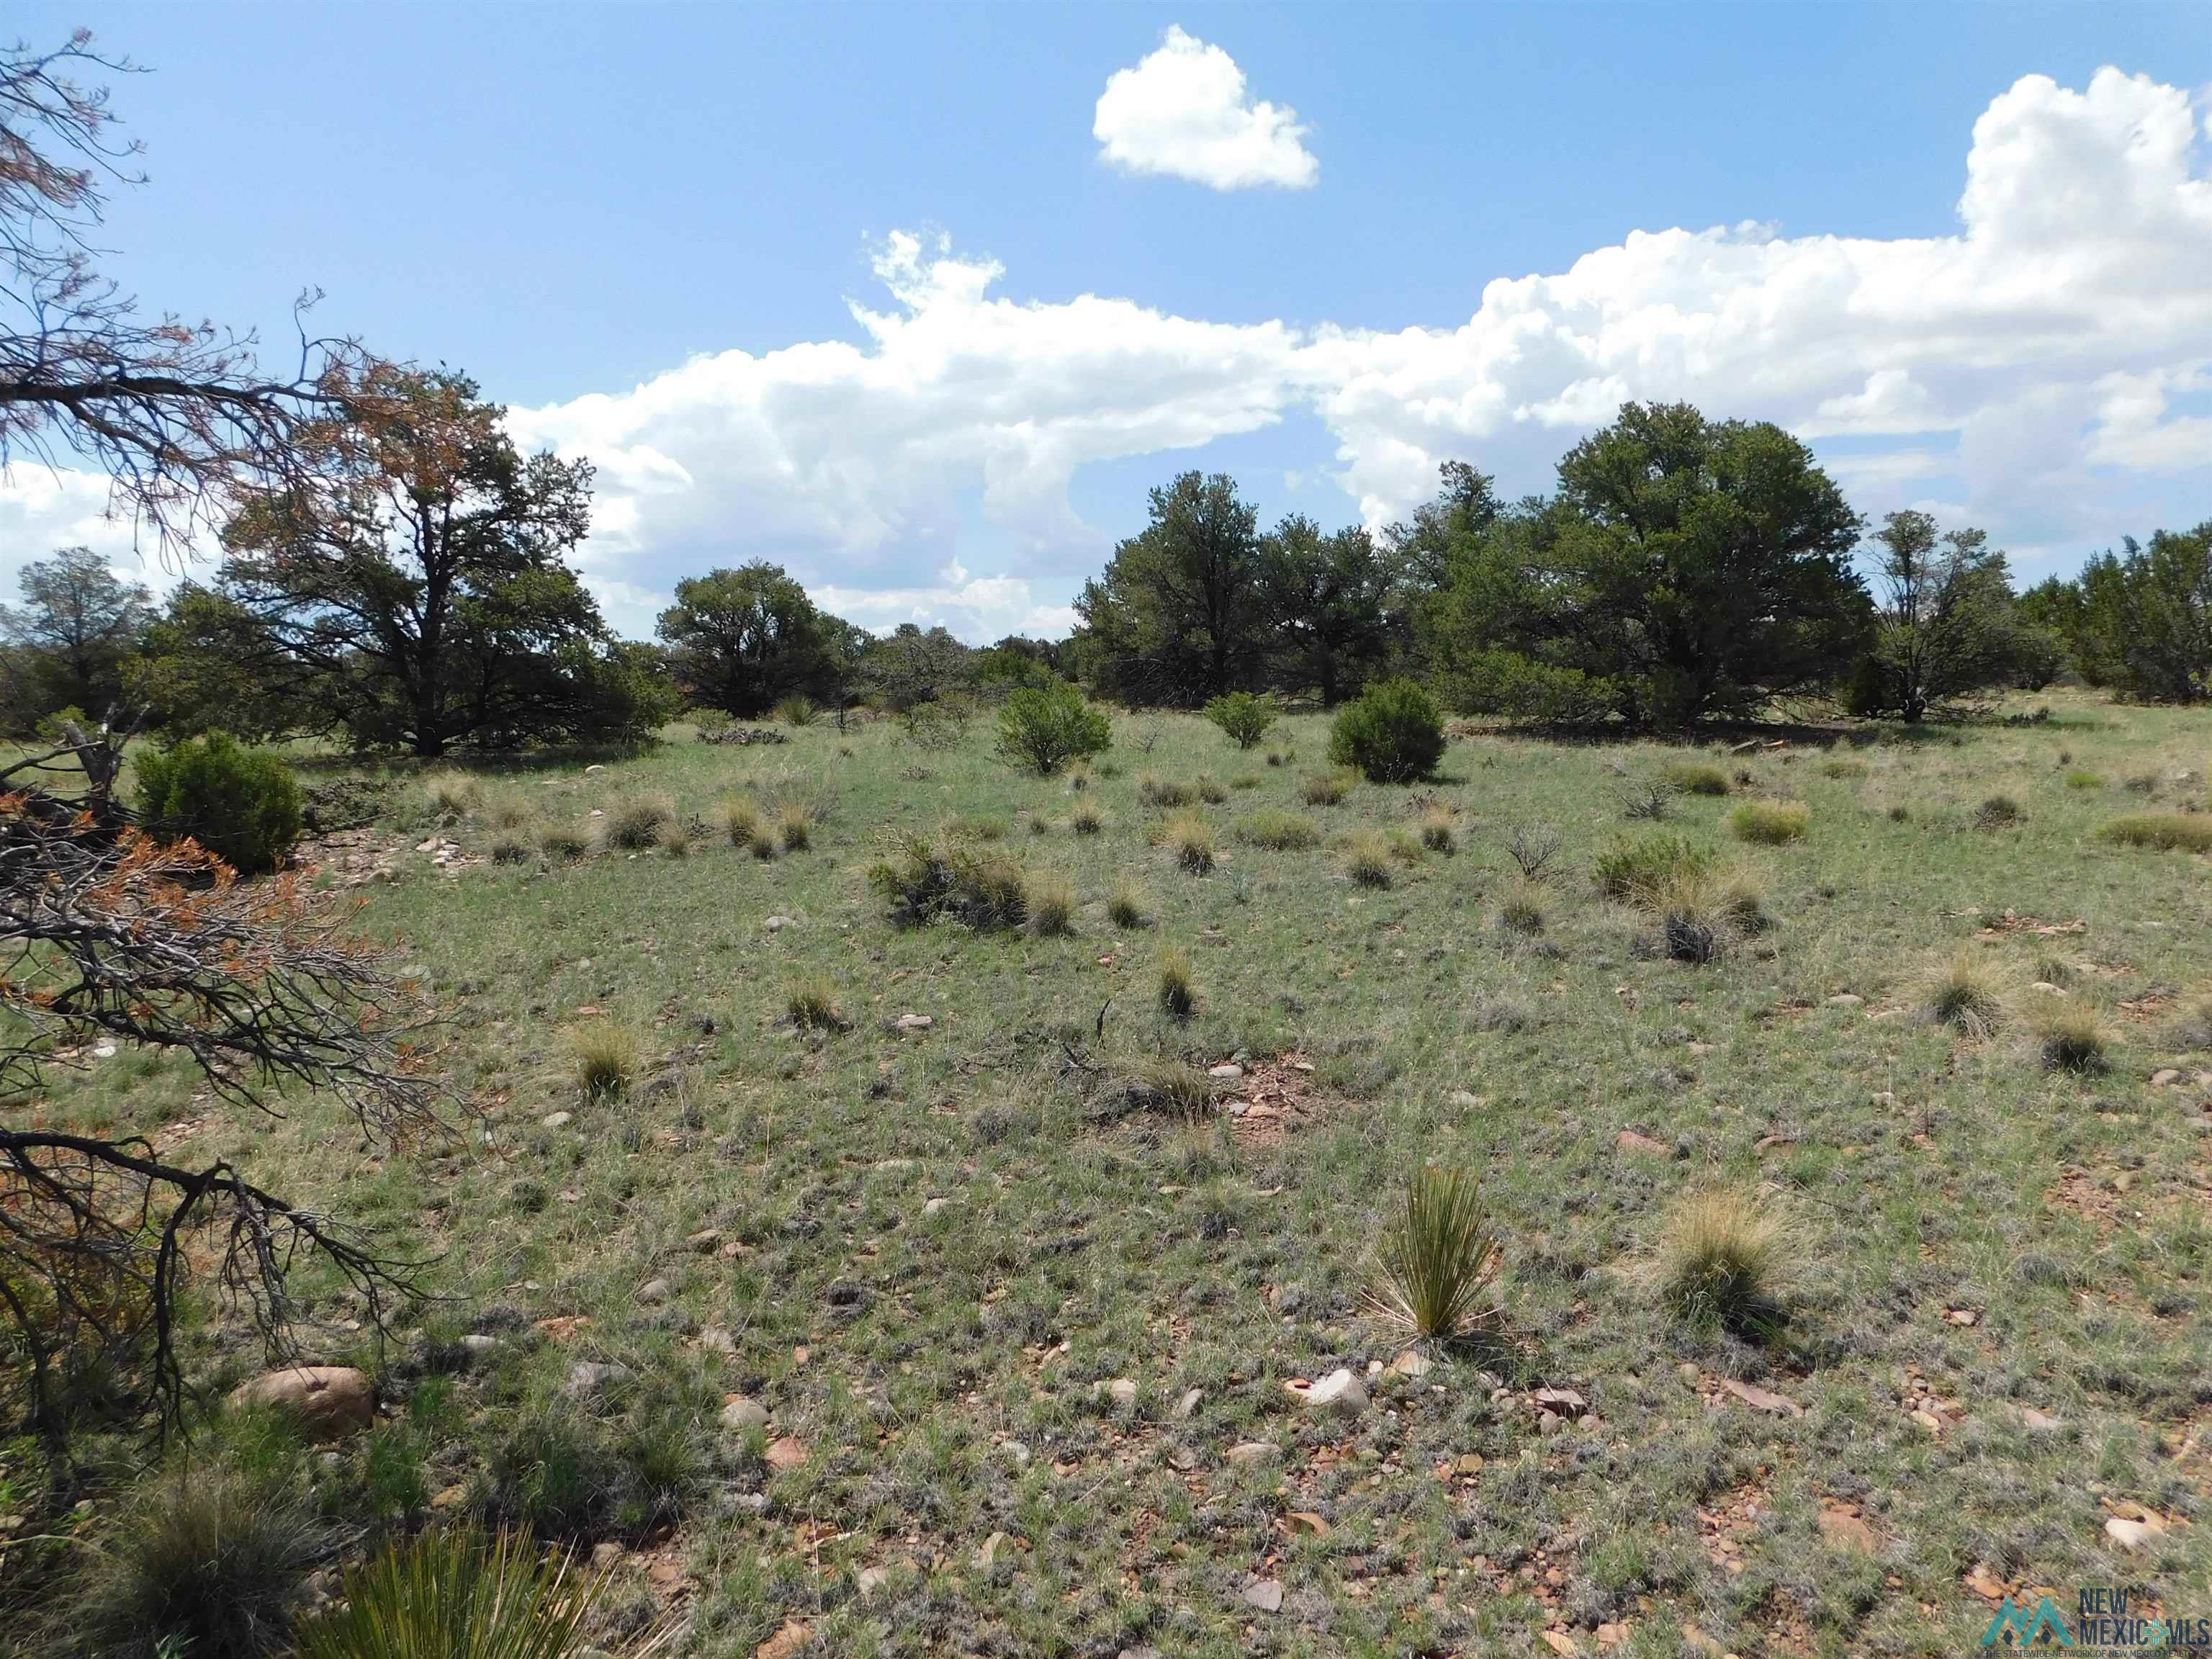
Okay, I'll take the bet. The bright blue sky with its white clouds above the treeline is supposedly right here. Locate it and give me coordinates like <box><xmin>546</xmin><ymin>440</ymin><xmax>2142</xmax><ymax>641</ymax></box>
<box><xmin>0</xmin><ymin>4</ymin><xmax>2212</xmax><ymax>633</ymax></box>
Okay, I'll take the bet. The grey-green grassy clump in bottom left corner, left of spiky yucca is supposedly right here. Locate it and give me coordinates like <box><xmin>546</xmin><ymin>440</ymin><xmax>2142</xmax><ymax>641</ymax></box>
<box><xmin>68</xmin><ymin>1457</ymin><xmax>336</xmax><ymax>1659</ymax></box>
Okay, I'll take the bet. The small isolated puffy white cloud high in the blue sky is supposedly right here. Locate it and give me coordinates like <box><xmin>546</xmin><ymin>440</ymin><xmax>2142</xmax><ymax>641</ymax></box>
<box><xmin>1090</xmin><ymin>27</ymin><xmax>1321</xmax><ymax>190</ymax></box>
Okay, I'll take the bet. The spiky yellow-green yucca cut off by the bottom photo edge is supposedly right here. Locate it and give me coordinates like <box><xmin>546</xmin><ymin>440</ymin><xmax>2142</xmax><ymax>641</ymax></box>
<box><xmin>299</xmin><ymin>1529</ymin><xmax>637</xmax><ymax>1659</ymax></box>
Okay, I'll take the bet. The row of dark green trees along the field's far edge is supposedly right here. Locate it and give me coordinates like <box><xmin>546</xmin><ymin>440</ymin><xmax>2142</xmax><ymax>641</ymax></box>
<box><xmin>0</xmin><ymin>380</ymin><xmax>2212</xmax><ymax>757</ymax></box>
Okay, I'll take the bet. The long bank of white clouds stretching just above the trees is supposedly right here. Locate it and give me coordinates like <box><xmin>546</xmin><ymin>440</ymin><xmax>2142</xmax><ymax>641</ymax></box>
<box><xmin>0</xmin><ymin>68</ymin><xmax>2212</xmax><ymax>637</ymax></box>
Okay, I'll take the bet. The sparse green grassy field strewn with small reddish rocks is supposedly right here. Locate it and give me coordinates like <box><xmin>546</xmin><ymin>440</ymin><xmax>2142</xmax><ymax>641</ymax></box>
<box><xmin>4</xmin><ymin>697</ymin><xmax>2212</xmax><ymax>1659</ymax></box>
